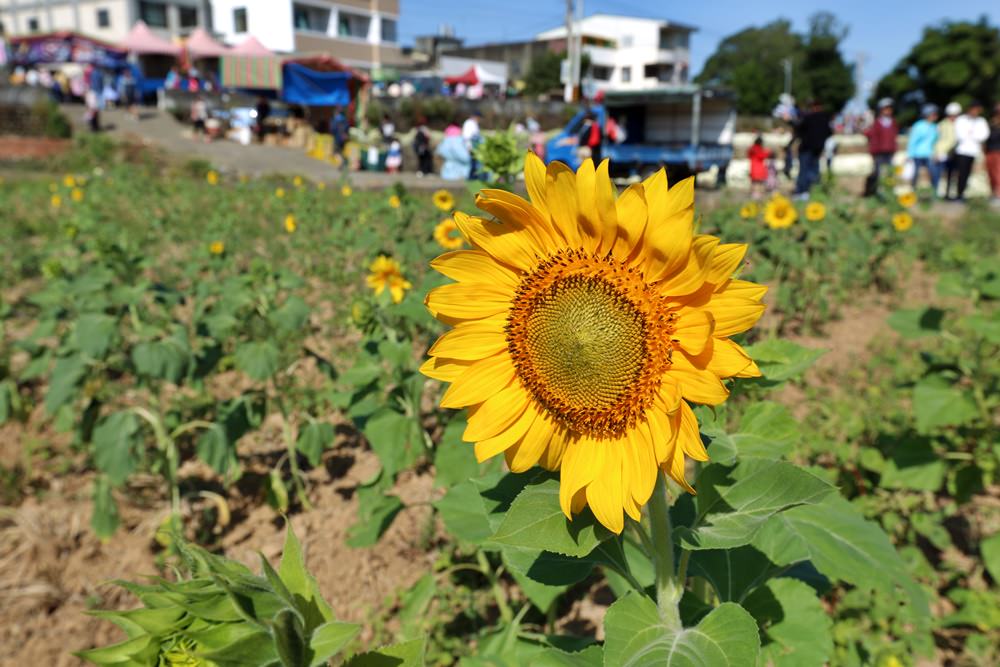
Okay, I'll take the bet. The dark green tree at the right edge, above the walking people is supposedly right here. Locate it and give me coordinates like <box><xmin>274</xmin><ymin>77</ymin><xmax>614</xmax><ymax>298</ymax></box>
<box><xmin>871</xmin><ymin>16</ymin><xmax>1000</xmax><ymax>119</ymax></box>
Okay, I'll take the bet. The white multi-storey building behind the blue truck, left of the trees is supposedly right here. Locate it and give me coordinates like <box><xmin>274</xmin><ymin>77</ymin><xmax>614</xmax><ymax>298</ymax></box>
<box><xmin>535</xmin><ymin>14</ymin><xmax>695</xmax><ymax>90</ymax></box>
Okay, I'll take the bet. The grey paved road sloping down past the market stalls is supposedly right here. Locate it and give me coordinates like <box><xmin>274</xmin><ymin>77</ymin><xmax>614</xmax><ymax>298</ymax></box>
<box><xmin>63</xmin><ymin>106</ymin><xmax>465</xmax><ymax>190</ymax></box>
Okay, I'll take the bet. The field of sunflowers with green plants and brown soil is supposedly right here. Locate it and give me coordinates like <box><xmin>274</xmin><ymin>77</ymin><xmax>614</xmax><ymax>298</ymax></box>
<box><xmin>0</xmin><ymin>137</ymin><xmax>1000</xmax><ymax>667</ymax></box>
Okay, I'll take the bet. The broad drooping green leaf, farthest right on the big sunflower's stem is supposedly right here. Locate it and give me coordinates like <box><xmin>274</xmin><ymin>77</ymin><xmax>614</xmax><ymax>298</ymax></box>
<box><xmin>753</xmin><ymin>494</ymin><xmax>930</xmax><ymax>618</ymax></box>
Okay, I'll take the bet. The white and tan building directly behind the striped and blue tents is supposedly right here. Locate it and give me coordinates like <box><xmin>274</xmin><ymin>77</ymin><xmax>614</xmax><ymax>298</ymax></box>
<box><xmin>212</xmin><ymin>0</ymin><xmax>403</xmax><ymax>69</ymax></box>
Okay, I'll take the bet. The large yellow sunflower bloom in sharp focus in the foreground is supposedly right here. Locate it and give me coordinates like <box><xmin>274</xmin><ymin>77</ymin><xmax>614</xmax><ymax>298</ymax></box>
<box><xmin>421</xmin><ymin>153</ymin><xmax>767</xmax><ymax>533</ymax></box>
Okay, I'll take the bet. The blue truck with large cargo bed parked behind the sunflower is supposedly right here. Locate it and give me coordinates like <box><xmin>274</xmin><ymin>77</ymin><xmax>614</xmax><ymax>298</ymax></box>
<box><xmin>545</xmin><ymin>85</ymin><xmax>736</xmax><ymax>179</ymax></box>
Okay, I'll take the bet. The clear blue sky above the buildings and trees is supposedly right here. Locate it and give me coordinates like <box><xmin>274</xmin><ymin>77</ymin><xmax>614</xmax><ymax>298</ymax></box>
<box><xmin>399</xmin><ymin>0</ymin><xmax>1000</xmax><ymax>90</ymax></box>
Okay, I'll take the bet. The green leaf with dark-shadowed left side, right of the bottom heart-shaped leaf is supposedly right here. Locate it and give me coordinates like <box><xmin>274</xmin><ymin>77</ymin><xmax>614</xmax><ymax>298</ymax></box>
<box><xmin>745</xmin><ymin>577</ymin><xmax>833</xmax><ymax>667</ymax></box>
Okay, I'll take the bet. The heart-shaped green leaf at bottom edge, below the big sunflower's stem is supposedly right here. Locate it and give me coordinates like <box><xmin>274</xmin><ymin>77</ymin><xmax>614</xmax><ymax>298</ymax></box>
<box><xmin>604</xmin><ymin>593</ymin><xmax>760</xmax><ymax>667</ymax></box>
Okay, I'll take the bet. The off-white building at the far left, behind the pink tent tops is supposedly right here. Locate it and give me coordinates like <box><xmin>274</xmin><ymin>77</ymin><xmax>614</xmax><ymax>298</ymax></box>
<box><xmin>0</xmin><ymin>0</ymin><xmax>211</xmax><ymax>43</ymax></box>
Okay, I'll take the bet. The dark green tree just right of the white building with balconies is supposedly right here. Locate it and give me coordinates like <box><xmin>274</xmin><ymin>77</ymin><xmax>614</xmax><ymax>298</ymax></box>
<box><xmin>695</xmin><ymin>12</ymin><xmax>854</xmax><ymax>115</ymax></box>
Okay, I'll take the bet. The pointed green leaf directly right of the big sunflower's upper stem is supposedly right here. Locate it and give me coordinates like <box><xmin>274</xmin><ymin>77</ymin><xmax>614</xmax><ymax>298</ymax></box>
<box><xmin>676</xmin><ymin>458</ymin><xmax>834</xmax><ymax>549</ymax></box>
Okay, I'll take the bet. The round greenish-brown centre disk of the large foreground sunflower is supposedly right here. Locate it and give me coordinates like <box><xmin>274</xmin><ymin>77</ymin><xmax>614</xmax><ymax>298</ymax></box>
<box><xmin>507</xmin><ymin>251</ymin><xmax>673</xmax><ymax>437</ymax></box>
